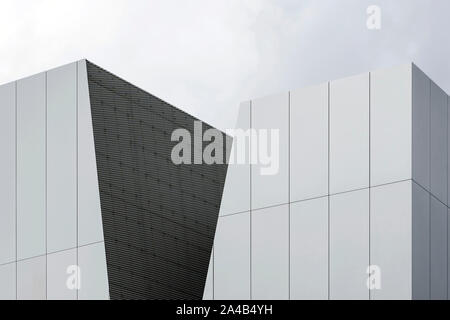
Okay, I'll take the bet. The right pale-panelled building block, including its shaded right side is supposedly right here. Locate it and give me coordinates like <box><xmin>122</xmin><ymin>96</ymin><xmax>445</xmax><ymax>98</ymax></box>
<box><xmin>204</xmin><ymin>64</ymin><xmax>450</xmax><ymax>300</ymax></box>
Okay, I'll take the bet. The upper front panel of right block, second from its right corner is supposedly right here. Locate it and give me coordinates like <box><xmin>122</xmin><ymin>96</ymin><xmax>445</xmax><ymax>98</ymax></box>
<box><xmin>330</xmin><ymin>74</ymin><xmax>369</xmax><ymax>194</ymax></box>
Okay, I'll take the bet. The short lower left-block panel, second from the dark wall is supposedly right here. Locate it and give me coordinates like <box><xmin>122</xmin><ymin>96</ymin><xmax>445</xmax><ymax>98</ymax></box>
<box><xmin>47</xmin><ymin>249</ymin><xmax>76</xmax><ymax>300</ymax></box>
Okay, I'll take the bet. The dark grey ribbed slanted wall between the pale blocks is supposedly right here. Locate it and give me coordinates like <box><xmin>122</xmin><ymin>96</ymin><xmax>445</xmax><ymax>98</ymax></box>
<box><xmin>87</xmin><ymin>62</ymin><xmax>227</xmax><ymax>299</ymax></box>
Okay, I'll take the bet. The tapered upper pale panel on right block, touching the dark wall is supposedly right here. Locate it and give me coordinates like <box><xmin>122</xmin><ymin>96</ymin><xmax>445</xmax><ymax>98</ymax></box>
<box><xmin>219</xmin><ymin>102</ymin><xmax>250</xmax><ymax>216</ymax></box>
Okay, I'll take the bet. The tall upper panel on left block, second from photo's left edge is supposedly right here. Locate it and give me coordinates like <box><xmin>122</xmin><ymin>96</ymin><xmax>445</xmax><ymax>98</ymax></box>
<box><xmin>17</xmin><ymin>73</ymin><xmax>46</xmax><ymax>260</ymax></box>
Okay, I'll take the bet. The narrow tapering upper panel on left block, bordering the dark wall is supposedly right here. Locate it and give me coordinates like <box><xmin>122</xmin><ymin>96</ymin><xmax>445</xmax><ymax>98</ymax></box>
<box><xmin>78</xmin><ymin>60</ymin><xmax>103</xmax><ymax>246</ymax></box>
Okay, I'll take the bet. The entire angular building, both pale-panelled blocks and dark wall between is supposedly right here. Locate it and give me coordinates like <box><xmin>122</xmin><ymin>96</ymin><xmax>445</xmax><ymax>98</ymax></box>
<box><xmin>0</xmin><ymin>60</ymin><xmax>450</xmax><ymax>300</ymax></box>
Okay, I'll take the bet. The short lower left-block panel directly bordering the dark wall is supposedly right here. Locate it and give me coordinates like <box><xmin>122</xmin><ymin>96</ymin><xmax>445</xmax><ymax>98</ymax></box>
<box><xmin>78</xmin><ymin>242</ymin><xmax>109</xmax><ymax>300</ymax></box>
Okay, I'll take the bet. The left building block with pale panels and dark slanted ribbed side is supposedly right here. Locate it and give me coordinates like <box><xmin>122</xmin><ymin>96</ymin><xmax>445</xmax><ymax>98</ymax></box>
<box><xmin>0</xmin><ymin>60</ymin><xmax>227</xmax><ymax>300</ymax></box>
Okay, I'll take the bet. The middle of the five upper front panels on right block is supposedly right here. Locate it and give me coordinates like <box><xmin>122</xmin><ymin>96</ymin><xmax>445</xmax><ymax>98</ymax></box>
<box><xmin>290</xmin><ymin>84</ymin><xmax>328</xmax><ymax>201</ymax></box>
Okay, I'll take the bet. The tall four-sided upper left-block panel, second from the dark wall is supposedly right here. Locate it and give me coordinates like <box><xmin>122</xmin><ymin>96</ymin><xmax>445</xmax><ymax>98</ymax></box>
<box><xmin>47</xmin><ymin>63</ymin><xmax>77</xmax><ymax>253</ymax></box>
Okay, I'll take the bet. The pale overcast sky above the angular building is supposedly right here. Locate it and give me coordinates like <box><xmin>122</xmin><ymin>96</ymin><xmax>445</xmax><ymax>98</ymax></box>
<box><xmin>0</xmin><ymin>0</ymin><xmax>450</xmax><ymax>129</ymax></box>
